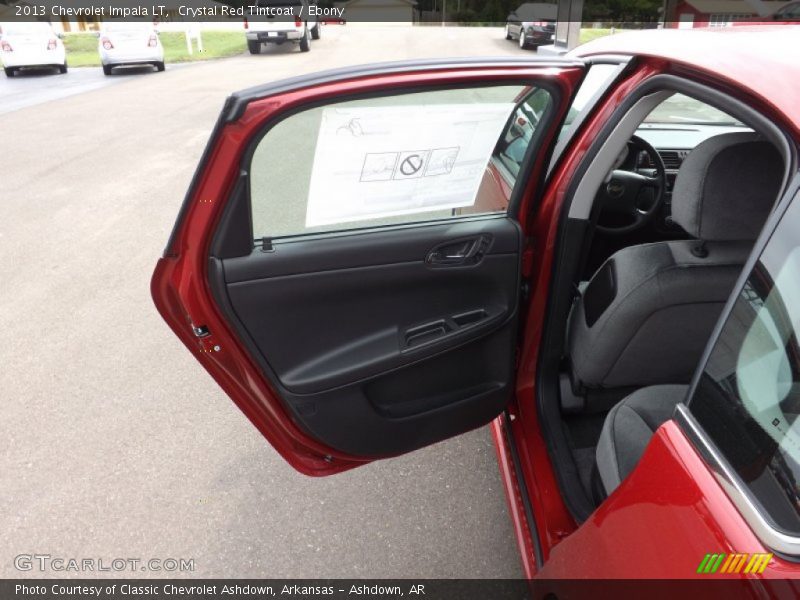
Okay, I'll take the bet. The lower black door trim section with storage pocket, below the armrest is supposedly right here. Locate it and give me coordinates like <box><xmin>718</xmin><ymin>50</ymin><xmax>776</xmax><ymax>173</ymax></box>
<box><xmin>287</xmin><ymin>324</ymin><xmax>516</xmax><ymax>456</ymax></box>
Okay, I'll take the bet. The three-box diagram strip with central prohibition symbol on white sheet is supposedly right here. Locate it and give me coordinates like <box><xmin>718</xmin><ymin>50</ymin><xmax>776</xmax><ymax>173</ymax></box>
<box><xmin>359</xmin><ymin>146</ymin><xmax>460</xmax><ymax>182</ymax></box>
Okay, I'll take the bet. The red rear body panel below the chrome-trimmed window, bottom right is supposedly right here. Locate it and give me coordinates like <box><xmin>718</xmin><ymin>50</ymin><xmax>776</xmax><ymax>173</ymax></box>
<box><xmin>539</xmin><ymin>421</ymin><xmax>800</xmax><ymax>579</ymax></box>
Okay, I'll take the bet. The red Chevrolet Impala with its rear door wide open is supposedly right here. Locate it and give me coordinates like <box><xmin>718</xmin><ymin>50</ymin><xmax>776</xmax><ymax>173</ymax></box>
<box><xmin>152</xmin><ymin>26</ymin><xmax>800</xmax><ymax>579</ymax></box>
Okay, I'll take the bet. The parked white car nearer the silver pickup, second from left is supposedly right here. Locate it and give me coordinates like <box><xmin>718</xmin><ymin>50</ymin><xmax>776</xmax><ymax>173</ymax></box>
<box><xmin>97</xmin><ymin>22</ymin><xmax>164</xmax><ymax>75</ymax></box>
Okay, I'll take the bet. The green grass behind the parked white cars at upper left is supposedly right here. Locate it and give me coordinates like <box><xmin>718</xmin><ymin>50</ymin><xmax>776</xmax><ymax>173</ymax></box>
<box><xmin>64</xmin><ymin>31</ymin><xmax>247</xmax><ymax>67</ymax></box>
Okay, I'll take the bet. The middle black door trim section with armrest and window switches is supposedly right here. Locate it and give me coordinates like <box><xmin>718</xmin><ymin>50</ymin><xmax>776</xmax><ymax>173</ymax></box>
<box><xmin>228</xmin><ymin>254</ymin><xmax>517</xmax><ymax>394</ymax></box>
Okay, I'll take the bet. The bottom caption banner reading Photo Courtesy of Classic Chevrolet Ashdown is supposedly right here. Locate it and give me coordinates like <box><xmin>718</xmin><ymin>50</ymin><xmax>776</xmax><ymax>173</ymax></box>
<box><xmin>0</xmin><ymin>577</ymin><xmax>800</xmax><ymax>600</ymax></box>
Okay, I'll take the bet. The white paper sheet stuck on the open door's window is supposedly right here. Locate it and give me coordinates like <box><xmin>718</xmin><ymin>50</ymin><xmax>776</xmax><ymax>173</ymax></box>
<box><xmin>306</xmin><ymin>103</ymin><xmax>514</xmax><ymax>227</ymax></box>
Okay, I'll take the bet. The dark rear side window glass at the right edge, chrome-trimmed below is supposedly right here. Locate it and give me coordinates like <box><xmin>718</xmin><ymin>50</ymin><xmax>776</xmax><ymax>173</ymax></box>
<box><xmin>690</xmin><ymin>200</ymin><xmax>800</xmax><ymax>534</ymax></box>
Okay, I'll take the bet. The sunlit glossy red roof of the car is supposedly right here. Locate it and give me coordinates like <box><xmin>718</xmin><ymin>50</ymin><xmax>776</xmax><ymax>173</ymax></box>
<box><xmin>568</xmin><ymin>25</ymin><xmax>800</xmax><ymax>132</ymax></box>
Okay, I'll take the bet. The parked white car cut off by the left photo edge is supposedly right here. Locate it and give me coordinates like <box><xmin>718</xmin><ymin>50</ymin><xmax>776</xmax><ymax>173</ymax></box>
<box><xmin>0</xmin><ymin>22</ymin><xmax>67</xmax><ymax>77</ymax></box>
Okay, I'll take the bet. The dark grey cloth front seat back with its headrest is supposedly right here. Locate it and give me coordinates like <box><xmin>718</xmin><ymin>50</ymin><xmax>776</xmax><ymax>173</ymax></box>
<box><xmin>568</xmin><ymin>132</ymin><xmax>784</xmax><ymax>393</ymax></box>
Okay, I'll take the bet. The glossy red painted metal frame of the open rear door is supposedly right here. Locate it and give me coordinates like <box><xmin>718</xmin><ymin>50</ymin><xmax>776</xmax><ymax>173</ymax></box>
<box><xmin>151</xmin><ymin>65</ymin><xmax>584</xmax><ymax>476</ymax></box>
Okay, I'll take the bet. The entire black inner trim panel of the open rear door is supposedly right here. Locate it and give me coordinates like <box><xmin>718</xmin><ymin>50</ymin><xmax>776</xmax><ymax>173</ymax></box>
<box><xmin>212</xmin><ymin>217</ymin><xmax>521</xmax><ymax>456</ymax></box>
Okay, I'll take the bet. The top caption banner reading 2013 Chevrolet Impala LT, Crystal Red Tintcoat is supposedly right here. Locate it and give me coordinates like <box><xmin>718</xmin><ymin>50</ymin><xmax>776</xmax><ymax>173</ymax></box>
<box><xmin>0</xmin><ymin>0</ymin><xmax>777</xmax><ymax>27</ymax></box>
